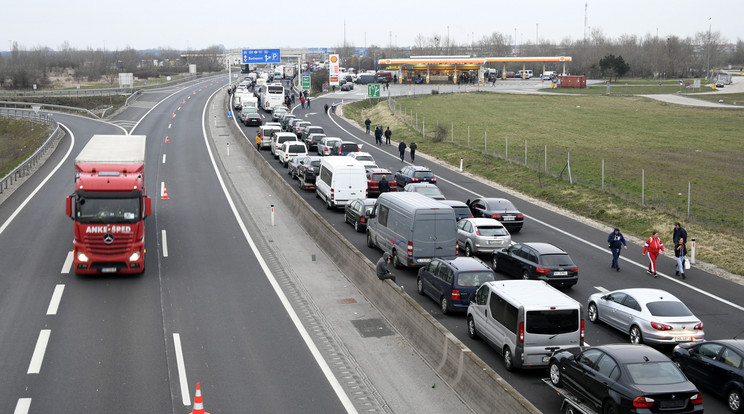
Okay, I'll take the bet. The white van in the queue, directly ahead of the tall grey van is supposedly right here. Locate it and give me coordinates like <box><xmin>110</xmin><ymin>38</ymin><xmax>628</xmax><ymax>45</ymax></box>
<box><xmin>315</xmin><ymin>157</ymin><xmax>367</xmax><ymax>209</ymax></box>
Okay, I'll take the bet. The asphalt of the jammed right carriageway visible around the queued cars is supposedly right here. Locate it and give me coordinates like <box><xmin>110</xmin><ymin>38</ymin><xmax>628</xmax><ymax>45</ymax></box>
<box><xmin>234</xmin><ymin>85</ymin><xmax>744</xmax><ymax>413</ymax></box>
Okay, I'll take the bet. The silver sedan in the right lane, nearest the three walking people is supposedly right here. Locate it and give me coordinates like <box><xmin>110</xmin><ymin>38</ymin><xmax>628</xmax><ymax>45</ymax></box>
<box><xmin>587</xmin><ymin>288</ymin><xmax>705</xmax><ymax>345</ymax></box>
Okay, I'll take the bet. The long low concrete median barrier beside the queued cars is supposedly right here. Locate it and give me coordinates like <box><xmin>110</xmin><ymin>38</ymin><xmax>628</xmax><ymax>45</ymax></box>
<box><xmin>218</xmin><ymin>94</ymin><xmax>540</xmax><ymax>413</ymax></box>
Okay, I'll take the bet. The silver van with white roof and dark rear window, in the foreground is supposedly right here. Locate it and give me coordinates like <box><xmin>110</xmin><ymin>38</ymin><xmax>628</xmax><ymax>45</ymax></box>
<box><xmin>467</xmin><ymin>280</ymin><xmax>584</xmax><ymax>371</ymax></box>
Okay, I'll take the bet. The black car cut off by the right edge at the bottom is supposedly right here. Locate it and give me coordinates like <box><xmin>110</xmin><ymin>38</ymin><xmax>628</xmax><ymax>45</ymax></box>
<box><xmin>672</xmin><ymin>339</ymin><xmax>744</xmax><ymax>413</ymax></box>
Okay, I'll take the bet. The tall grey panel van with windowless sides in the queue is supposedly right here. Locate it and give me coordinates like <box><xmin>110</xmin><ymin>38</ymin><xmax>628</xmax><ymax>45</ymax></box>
<box><xmin>366</xmin><ymin>192</ymin><xmax>457</xmax><ymax>267</ymax></box>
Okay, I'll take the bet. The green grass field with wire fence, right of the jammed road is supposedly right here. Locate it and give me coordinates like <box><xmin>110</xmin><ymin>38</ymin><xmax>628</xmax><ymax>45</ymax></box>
<box><xmin>344</xmin><ymin>93</ymin><xmax>744</xmax><ymax>274</ymax></box>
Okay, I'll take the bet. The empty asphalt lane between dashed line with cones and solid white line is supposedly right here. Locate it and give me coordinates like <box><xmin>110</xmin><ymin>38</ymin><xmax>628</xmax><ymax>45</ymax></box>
<box><xmin>151</xmin><ymin>94</ymin><xmax>343</xmax><ymax>412</ymax></box>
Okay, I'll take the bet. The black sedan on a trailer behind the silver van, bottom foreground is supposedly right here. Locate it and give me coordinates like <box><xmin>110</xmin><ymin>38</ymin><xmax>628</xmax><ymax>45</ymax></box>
<box><xmin>549</xmin><ymin>344</ymin><xmax>703</xmax><ymax>414</ymax></box>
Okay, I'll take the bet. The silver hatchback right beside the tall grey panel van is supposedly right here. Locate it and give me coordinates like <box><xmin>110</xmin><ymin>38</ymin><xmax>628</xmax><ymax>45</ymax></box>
<box><xmin>457</xmin><ymin>218</ymin><xmax>511</xmax><ymax>256</ymax></box>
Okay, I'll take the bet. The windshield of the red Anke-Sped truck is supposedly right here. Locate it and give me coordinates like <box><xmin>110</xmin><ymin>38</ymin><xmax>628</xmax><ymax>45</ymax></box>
<box><xmin>75</xmin><ymin>197</ymin><xmax>142</xmax><ymax>223</ymax></box>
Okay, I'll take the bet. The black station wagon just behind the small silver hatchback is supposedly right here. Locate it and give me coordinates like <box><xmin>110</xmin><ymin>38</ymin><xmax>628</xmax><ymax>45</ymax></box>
<box><xmin>491</xmin><ymin>243</ymin><xmax>579</xmax><ymax>288</ymax></box>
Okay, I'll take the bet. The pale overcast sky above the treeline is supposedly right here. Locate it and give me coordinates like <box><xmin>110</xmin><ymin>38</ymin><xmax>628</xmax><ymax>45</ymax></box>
<box><xmin>0</xmin><ymin>0</ymin><xmax>744</xmax><ymax>50</ymax></box>
